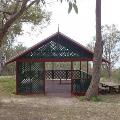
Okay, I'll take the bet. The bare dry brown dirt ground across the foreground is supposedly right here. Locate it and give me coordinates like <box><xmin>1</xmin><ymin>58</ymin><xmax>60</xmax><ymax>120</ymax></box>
<box><xmin>0</xmin><ymin>95</ymin><xmax>120</xmax><ymax>120</ymax></box>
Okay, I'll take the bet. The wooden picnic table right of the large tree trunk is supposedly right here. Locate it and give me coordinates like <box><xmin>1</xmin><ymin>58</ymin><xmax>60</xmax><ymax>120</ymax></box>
<box><xmin>100</xmin><ymin>82</ymin><xmax>120</xmax><ymax>93</ymax></box>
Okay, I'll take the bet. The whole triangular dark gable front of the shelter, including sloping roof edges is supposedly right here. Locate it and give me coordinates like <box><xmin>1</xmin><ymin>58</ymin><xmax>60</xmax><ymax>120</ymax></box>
<box><xmin>5</xmin><ymin>33</ymin><xmax>109</xmax><ymax>63</ymax></box>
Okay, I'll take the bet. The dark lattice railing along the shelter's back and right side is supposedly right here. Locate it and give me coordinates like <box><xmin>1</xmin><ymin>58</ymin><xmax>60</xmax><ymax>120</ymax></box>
<box><xmin>45</xmin><ymin>70</ymin><xmax>92</xmax><ymax>95</ymax></box>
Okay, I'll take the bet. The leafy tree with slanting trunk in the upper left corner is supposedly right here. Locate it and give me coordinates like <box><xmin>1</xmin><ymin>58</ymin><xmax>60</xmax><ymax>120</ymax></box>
<box><xmin>0</xmin><ymin>0</ymin><xmax>50</xmax><ymax>72</ymax></box>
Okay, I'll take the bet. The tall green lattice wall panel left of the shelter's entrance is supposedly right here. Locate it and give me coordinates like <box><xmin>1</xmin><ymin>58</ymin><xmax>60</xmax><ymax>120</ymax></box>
<box><xmin>18</xmin><ymin>62</ymin><xmax>44</xmax><ymax>93</ymax></box>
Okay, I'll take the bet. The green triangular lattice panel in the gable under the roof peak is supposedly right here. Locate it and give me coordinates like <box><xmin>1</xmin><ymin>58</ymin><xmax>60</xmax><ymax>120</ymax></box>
<box><xmin>22</xmin><ymin>41</ymin><xmax>91</xmax><ymax>58</ymax></box>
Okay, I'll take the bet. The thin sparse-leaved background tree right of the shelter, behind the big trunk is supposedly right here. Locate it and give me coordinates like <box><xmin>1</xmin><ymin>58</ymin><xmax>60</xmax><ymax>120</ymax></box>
<box><xmin>88</xmin><ymin>24</ymin><xmax>120</xmax><ymax>80</ymax></box>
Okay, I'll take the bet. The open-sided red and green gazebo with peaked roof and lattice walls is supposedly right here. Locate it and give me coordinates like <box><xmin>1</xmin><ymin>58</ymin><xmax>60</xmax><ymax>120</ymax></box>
<box><xmin>6</xmin><ymin>32</ymin><xmax>108</xmax><ymax>95</ymax></box>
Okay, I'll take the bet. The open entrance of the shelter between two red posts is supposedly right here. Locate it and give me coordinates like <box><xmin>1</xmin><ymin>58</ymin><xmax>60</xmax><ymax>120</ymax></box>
<box><xmin>45</xmin><ymin>62</ymin><xmax>71</xmax><ymax>97</ymax></box>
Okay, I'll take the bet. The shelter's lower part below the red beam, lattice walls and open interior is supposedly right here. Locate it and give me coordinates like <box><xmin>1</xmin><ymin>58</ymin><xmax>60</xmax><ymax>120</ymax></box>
<box><xmin>18</xmin><ymin>62</ymin><xmax>91</xmax><ymax>96</ymax></box>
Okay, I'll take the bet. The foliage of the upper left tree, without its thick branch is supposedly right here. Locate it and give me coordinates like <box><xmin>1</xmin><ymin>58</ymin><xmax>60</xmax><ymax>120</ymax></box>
<box><xmin>0</xmin><ymin>0</ymin><xmax>51</xmax><ymax>44</ymax></box>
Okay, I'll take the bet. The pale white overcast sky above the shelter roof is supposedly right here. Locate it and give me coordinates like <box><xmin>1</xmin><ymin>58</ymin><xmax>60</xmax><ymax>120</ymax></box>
<box><xmin>16</xmin><ymin>0</ymin><xmax>120</xmax><ymax>66</ymax></box>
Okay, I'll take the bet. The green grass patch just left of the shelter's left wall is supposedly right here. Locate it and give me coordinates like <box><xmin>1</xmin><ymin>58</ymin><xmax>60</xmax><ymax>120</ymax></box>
<box><xmin>0</xmin><ymin>76</ymin><xmax>16</xmax><ymax>95</ymax></box>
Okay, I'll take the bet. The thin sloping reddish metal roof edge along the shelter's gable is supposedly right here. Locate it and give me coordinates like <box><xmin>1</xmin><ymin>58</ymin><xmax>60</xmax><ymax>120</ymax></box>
<box><xmin>6</xmin><ymin>32</ymin><xmax>109</xmax><ymax>64</ymax></box>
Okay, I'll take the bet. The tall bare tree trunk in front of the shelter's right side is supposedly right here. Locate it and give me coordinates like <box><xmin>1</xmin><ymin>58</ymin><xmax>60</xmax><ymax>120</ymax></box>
<box><xmin>86</xmin><ymin>0</ymin><xmax>103</xmax><ymax>100</ymax></box>
